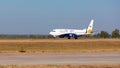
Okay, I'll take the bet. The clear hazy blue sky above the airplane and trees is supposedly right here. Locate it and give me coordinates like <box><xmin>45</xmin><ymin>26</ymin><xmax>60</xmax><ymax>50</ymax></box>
<box><xmin>0</xmin><ymin>0</ymin><xmax>120</xmax><ymax>34</ymax></box>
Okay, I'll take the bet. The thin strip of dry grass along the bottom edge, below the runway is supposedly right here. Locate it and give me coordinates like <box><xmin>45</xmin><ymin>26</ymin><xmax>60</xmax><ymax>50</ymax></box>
<box><xmin>0</xmin><ymin>65</ymin><xmax>120</xmax><ymax>68</ymax></box>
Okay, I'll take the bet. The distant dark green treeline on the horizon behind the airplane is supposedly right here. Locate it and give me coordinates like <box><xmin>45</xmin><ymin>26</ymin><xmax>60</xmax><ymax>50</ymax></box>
<box><xmin>0</xmin><ymin>29</ymin><xmax>120</xmax><ymax>39</ymax></box>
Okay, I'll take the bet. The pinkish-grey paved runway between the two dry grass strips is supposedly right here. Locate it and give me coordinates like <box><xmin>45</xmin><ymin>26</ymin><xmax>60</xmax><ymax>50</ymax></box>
<box><xmin>0</xmin><ymin>52</ymin><xmax>120</xmax><ymax>65</ymax></box>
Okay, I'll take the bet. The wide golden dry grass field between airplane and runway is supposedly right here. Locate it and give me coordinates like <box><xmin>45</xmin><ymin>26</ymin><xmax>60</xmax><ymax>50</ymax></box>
<box><xmin>0</xmin><ymin>39</ymin><xmax>120</xmax><ymax>53</ymax></box>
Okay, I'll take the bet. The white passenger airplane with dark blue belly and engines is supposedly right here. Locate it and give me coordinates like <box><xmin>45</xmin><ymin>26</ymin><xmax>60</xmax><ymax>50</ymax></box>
<box><xmin>49</xmin><ymin>20</ymin><xmax>94</xmax><ymax>39</ymax></box>
